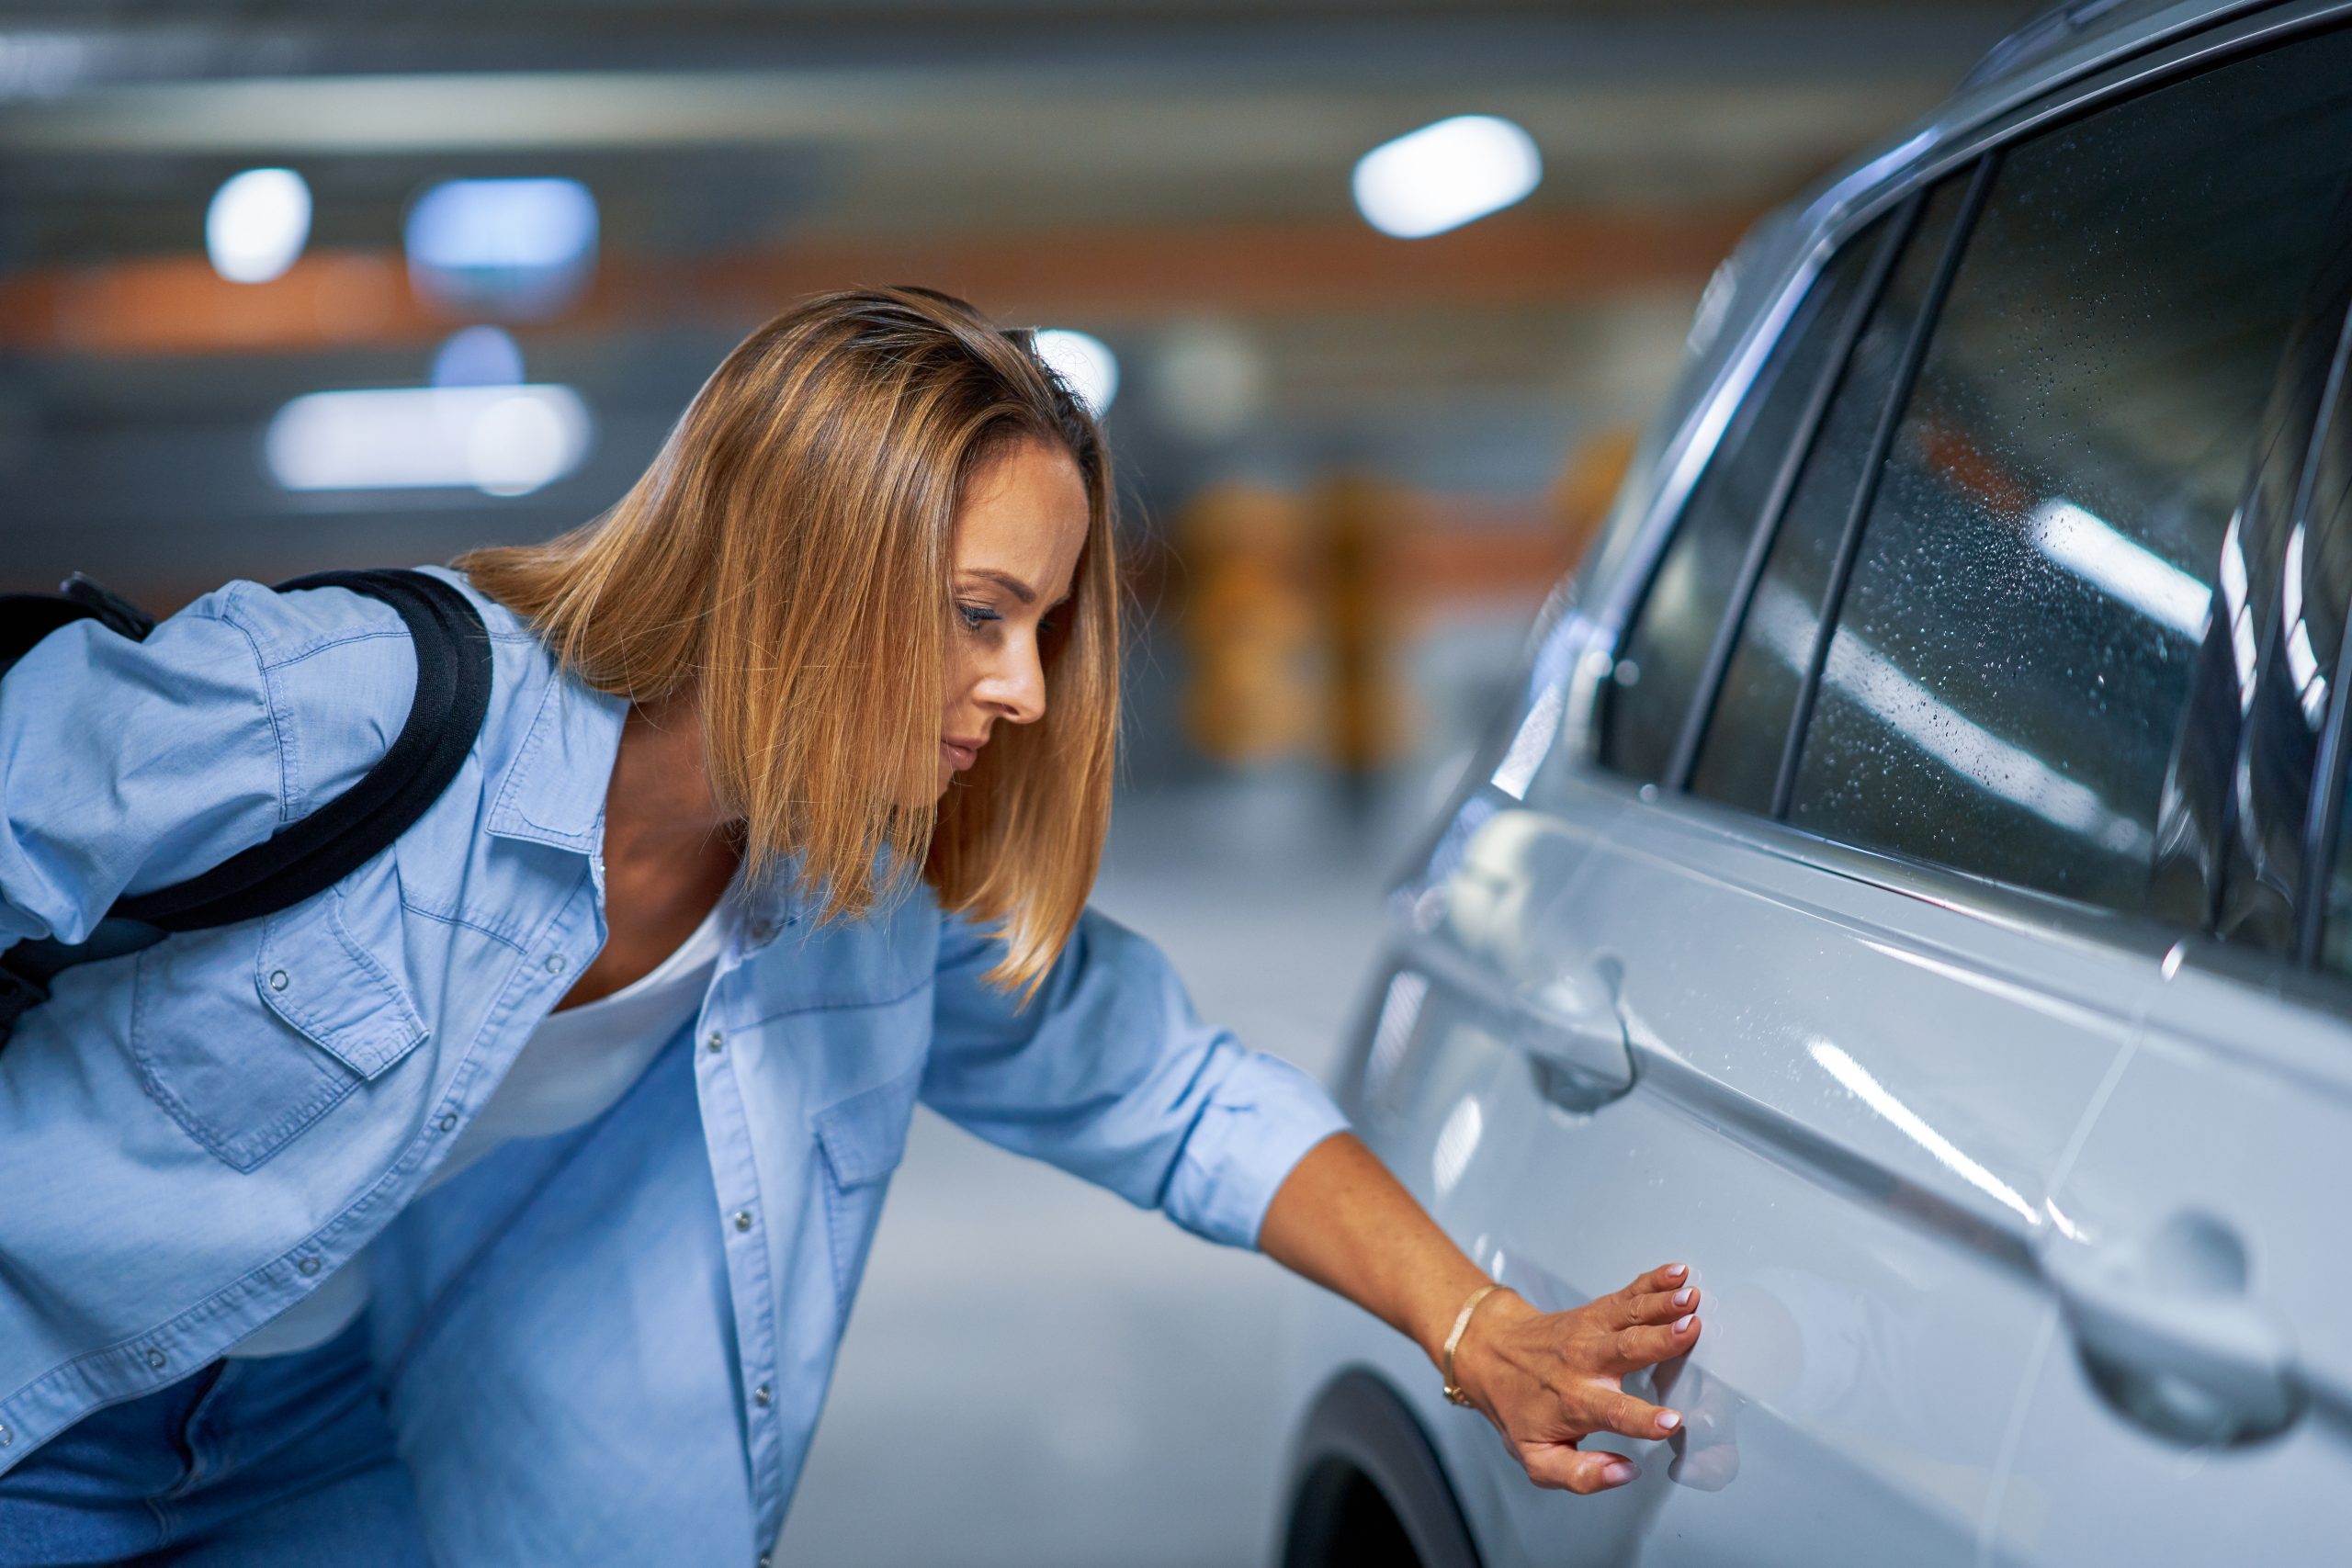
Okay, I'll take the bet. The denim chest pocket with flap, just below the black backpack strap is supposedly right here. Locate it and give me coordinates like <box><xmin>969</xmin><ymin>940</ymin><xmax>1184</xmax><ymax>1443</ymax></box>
<box><xmin>130</xmin><ymin>884</ymin><xmax>428</xmax><ymax>1170</ymax></box>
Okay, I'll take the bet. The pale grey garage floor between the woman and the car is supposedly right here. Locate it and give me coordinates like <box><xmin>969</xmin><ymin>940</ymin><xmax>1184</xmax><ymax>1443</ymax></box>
<box><xmin>778</xmin><ymin>781</ymin><xmax>1420</xmax><ymax>1568</ymax></box>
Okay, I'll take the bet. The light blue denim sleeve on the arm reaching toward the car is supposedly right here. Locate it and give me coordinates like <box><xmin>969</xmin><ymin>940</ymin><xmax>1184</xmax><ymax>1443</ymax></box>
<box><xmin>922</xmin><ymin>909</ymin><xmax>1348</xmax><ymax>1246</ymax></box>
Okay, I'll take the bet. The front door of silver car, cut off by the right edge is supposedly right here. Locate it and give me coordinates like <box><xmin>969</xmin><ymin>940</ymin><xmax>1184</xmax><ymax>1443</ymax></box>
<box><xmin>1992</xmin><ymin>125</ymin><xmax>2352</xmax><ymax>1565</ymax></box>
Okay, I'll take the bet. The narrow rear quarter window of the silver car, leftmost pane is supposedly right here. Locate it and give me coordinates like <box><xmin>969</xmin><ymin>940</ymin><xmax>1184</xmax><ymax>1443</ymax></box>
<box><xmin>1600</xmin><ymin>231</ymin><xmax>1877</xmax><ymax>778</ymax></box>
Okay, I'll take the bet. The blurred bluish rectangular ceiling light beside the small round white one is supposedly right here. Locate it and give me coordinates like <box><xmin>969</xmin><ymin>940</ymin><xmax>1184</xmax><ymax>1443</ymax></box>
<box><xmin>407</xmin><ymin>179</ymin><xmax>597</xmax><ymax>315</ymax></box>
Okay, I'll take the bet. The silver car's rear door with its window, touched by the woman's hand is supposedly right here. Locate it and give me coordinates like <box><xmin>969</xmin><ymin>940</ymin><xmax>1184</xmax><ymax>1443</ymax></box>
<box><xmin>1399</xmin><ymin>15</ymin><xmax>2352</xmax><ymax>1563</ymax></box>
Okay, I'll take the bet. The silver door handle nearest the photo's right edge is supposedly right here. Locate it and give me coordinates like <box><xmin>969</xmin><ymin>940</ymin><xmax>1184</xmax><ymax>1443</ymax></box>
<box><xmin>2041</xmin><ymin>1213</ymin><xmax>2305</xmax><ymax>1443</ymax></box>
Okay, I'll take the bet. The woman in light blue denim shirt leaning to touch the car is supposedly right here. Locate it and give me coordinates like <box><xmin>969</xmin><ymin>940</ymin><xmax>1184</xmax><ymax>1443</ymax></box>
<box><xmin>0</xmin><ymin>289</ymin><xmax>1698</xmax><ymax>1565</ymax></box>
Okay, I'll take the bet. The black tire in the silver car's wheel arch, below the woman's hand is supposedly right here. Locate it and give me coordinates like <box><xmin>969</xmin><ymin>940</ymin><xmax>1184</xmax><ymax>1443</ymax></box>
<box><xmin>1282</xmin><ymin>1371</ymin><xmax>1479</xmax><ymax>1568</ymax></box>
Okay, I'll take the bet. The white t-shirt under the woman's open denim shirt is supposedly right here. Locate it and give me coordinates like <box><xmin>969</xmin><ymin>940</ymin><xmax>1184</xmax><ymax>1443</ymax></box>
<box><xmin>228</xmin><ymin>900</ymin><xmax>724</xmax><ymax>1357</ymax></box>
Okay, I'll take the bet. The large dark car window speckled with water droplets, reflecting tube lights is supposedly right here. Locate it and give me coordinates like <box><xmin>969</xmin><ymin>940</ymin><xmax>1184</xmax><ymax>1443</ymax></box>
<box><xmin>1790</xmin><ymin>35</ymin><xmax>2352</xmax><ymax>909</ymax></box>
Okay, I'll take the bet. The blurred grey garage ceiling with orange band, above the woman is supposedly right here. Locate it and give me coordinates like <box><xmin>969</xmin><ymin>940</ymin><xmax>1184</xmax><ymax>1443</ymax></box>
<box><xmin>0</xmin><ymin>0</ymin><xmax>2020</xmax><ymax>602</ymax></box>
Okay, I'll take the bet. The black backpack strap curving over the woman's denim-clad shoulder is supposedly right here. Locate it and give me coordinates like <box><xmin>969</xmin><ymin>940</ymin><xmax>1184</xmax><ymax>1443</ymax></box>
<box><xmin>110</xmin><ymin>571</ymin><xmax>492</xmax><ymax>931</ymax></box>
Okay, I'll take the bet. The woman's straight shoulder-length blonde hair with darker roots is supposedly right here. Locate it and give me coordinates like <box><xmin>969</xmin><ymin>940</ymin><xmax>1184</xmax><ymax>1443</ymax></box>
<box><xmin>457</xmin><ymin>289</ymin><xmax>1120</xmax><ymax>995</ymax></box>
